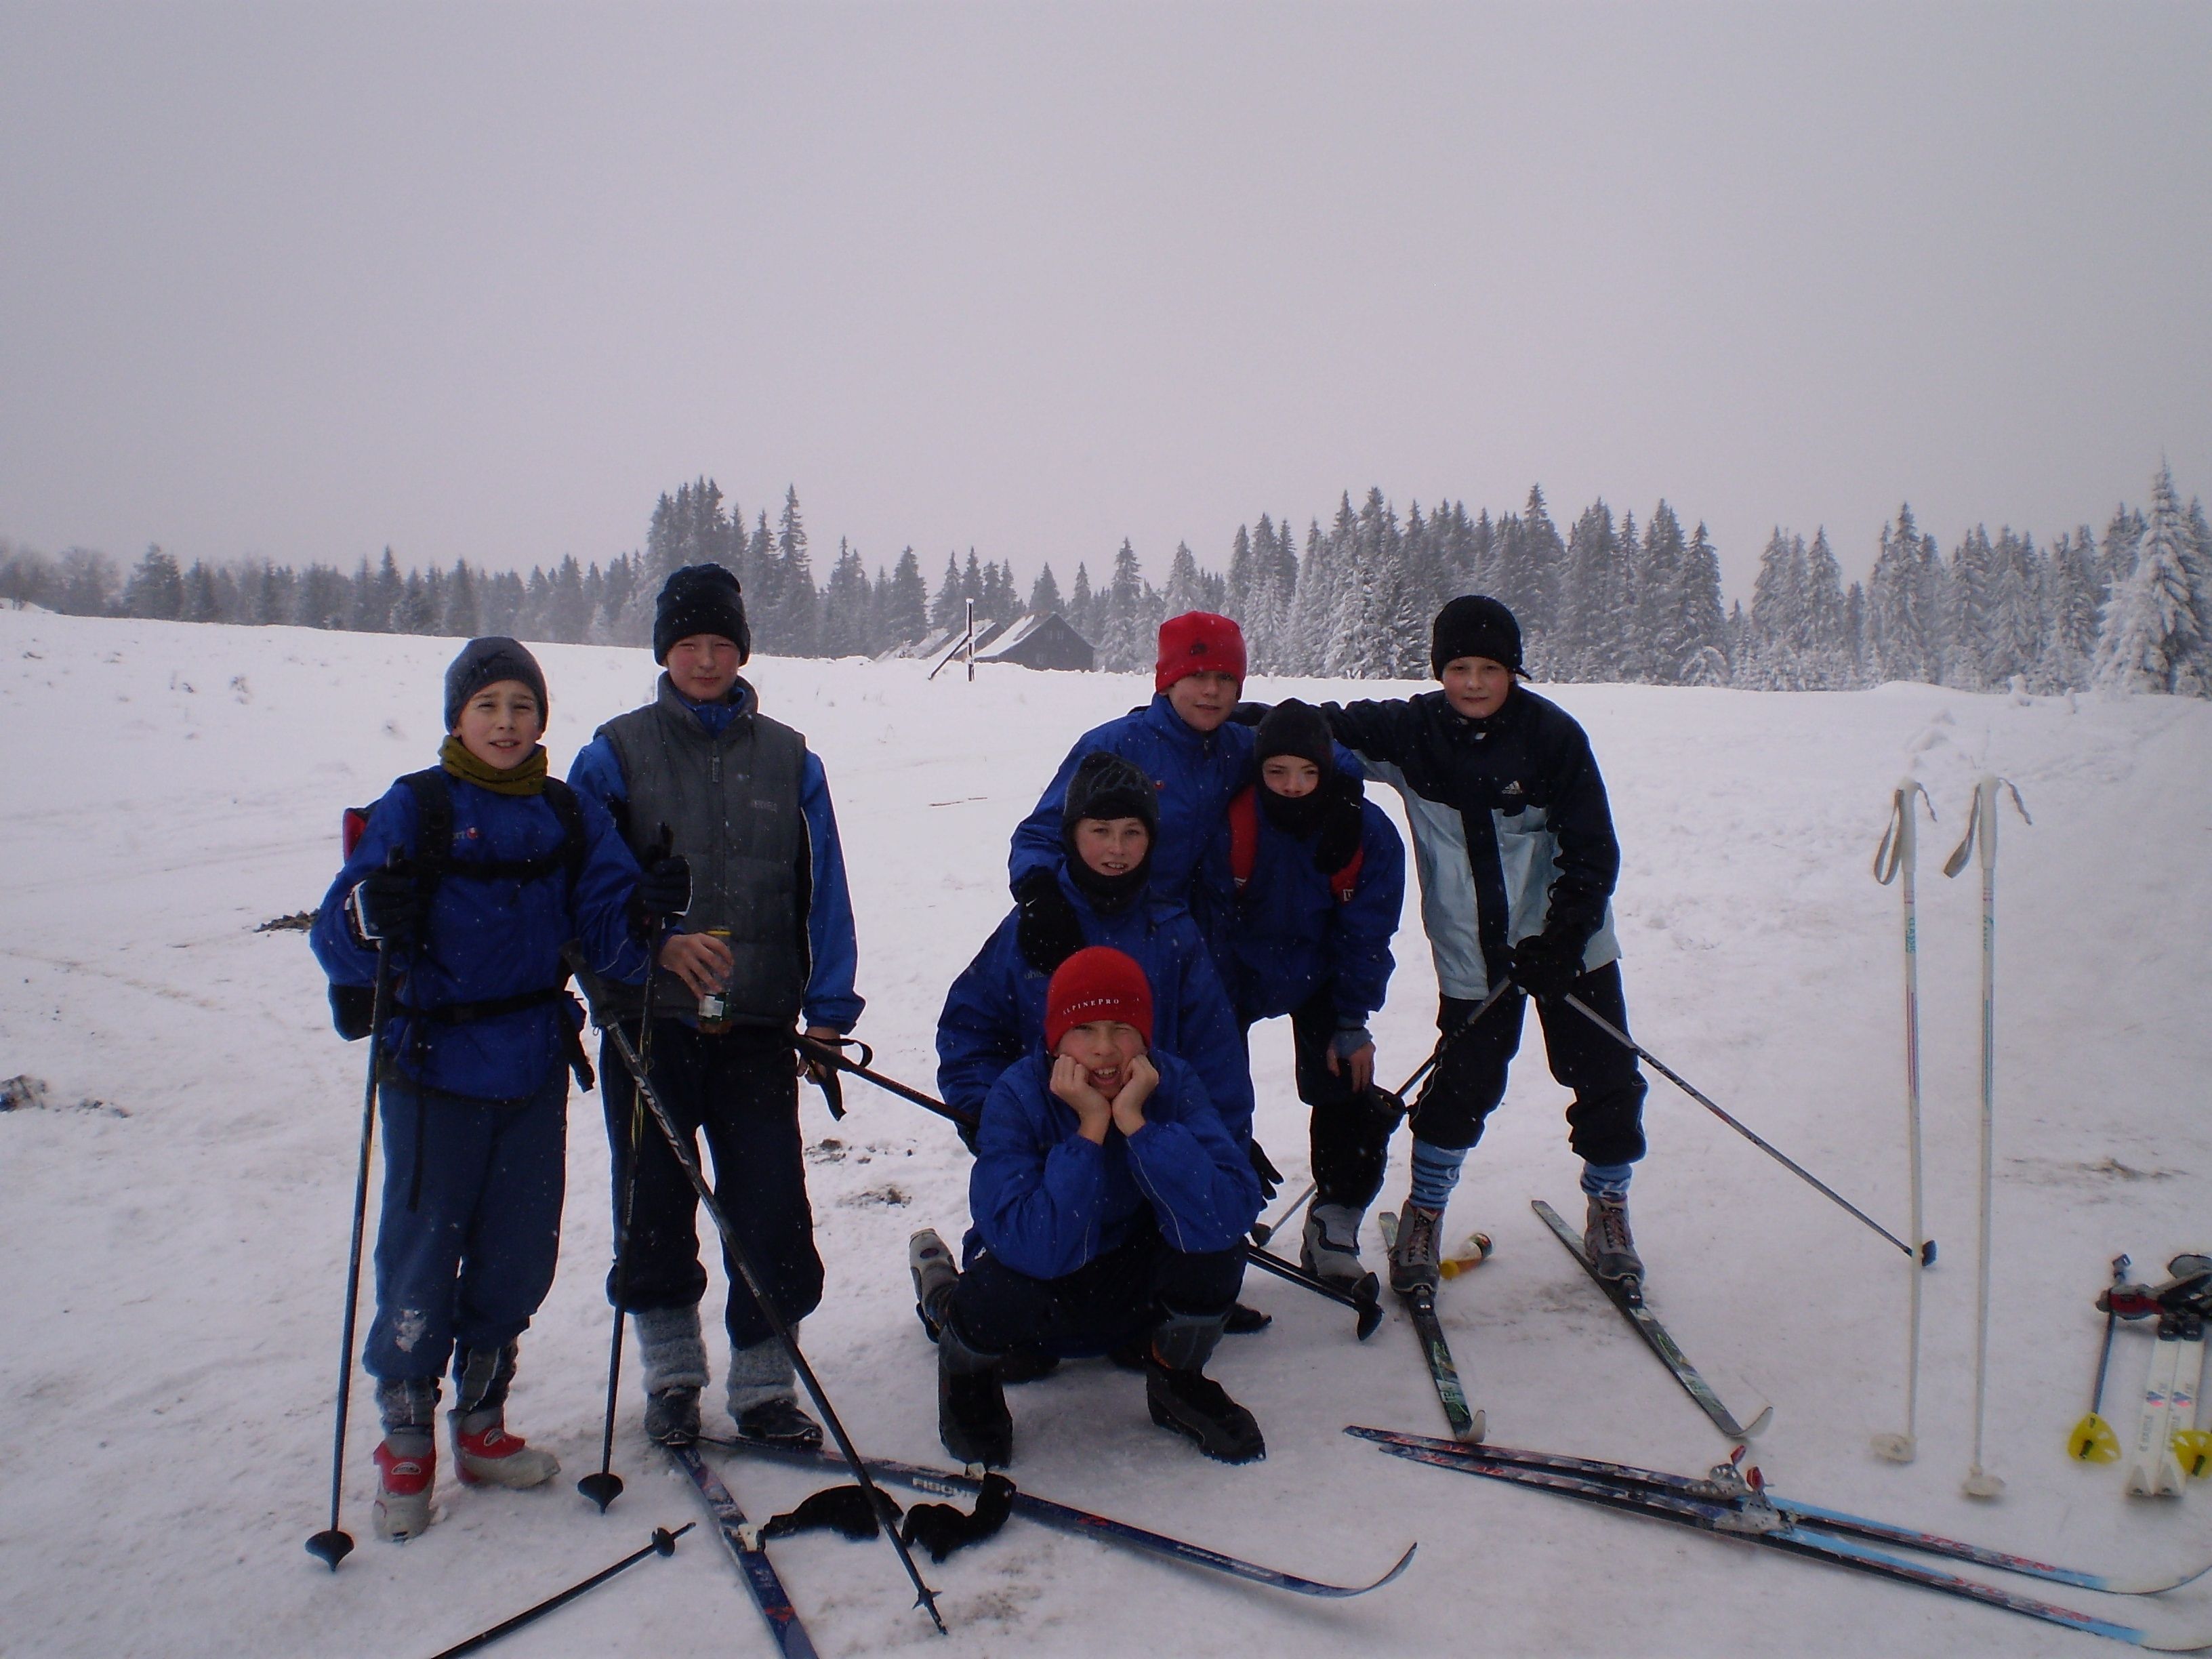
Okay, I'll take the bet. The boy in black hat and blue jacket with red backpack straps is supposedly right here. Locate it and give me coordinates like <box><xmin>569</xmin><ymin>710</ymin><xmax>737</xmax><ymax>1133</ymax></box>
<box><xmin>1225</xmin><ymin>699</ymin><xmax>1405</xmax><ymax>1290</ymax></box>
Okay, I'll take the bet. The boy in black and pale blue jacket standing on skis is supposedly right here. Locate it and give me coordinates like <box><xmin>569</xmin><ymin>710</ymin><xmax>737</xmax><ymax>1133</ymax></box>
<box><xmin>1323</xmin><ymin>595</ymin><xmax>1643</xmax><ymax>1292</ymax></box>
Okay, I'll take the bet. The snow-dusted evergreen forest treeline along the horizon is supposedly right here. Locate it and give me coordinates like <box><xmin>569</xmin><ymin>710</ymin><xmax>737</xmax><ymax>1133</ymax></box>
<box><xmin>0</xmin><ymin>467</ymin><xmax>2212</xmax><ymax>697</ymax></box>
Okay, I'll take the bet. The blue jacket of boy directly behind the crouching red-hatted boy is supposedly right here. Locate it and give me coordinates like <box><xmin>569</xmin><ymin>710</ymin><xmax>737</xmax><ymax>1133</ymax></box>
<box><xmin>938</xmin><ymin>858</ymin><xmax>1252</xmax><ymax>1146</ymax></box>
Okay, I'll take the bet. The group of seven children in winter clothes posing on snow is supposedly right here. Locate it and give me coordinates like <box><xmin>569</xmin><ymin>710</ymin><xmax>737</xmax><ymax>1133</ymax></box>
<box><xmin>312</xmin><ymin>564</ymin><xmax>1643</xmax><ymax>1537</ymax></box>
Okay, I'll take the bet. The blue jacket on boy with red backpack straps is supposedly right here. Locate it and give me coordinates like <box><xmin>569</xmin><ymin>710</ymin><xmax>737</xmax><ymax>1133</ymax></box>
<box><xmin>1223</xmin><ymin>800</ymin><xmax>1405</xmax><ymax>1026</ymax></box>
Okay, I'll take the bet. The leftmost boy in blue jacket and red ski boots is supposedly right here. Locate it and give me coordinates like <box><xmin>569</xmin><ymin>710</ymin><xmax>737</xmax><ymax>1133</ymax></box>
<box><xmin>312</xmin><ymin>639</ymin><xmax>663</xmax><ymax>1540</ymax></box>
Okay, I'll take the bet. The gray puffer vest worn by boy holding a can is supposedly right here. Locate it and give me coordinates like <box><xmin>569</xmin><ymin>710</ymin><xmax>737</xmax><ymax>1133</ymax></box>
<box><xmin>586</xmin><ymin>675</ymin><xmax>814</xmax><ymax>1026</ymax></box>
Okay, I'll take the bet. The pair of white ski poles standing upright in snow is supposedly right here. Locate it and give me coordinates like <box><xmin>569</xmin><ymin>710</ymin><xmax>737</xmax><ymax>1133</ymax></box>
<box><xmin>1874</xmin><ymin>772</ymin><xmax>2033</xmax><ymax>1498</ymax></box>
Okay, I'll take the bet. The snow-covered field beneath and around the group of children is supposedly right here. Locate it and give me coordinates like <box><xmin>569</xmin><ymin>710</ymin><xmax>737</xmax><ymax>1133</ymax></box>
<box><xmin>0</xmin><ymin>613</ymin><xmax>2212</xmax><ymax>1659</ymax></box>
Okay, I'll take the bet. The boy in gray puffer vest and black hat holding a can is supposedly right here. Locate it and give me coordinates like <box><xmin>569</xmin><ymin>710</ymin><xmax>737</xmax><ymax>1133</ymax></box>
<box><xmin>569</xmin><ymin>564</ymin><xmax>861</xmax><ymax>1449</ymax></box>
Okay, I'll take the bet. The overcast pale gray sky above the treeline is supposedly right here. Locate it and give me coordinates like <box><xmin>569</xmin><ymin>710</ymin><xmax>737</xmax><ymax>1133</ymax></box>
<box><xmin>0</xmin><ymin>0</ymin><xmax>2212</xmax><ymax>595</ymax></box>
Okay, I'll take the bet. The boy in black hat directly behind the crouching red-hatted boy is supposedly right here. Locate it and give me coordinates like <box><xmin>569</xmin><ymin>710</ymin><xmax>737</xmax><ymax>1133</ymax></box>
<box><xmin>938</xmin><ymin>752</ymin><xmax>1252</xmax><ymax>1143</ymax></box>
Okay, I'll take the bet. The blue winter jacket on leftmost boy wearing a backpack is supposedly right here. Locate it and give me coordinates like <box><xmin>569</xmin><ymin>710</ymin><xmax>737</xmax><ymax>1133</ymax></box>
<box><xmin>310</xmin><ymin>774</ymin><xmax>646</xmax><ymax>1099</ymax></box>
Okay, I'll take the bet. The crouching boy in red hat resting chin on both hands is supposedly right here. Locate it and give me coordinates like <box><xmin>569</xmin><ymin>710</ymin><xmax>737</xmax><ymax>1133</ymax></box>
<box><xmin>924</xmin><ymin>945</ymin><xmax>1267</xmax><ymax>1465</ymax></box>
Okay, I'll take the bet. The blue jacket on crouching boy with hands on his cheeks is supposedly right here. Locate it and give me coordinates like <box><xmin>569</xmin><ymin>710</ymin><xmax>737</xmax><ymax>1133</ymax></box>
<box><xmin>969</xmin><ymin>1044</ymin><xmax>1258</xmax><ymax>1279</ymax></box>
